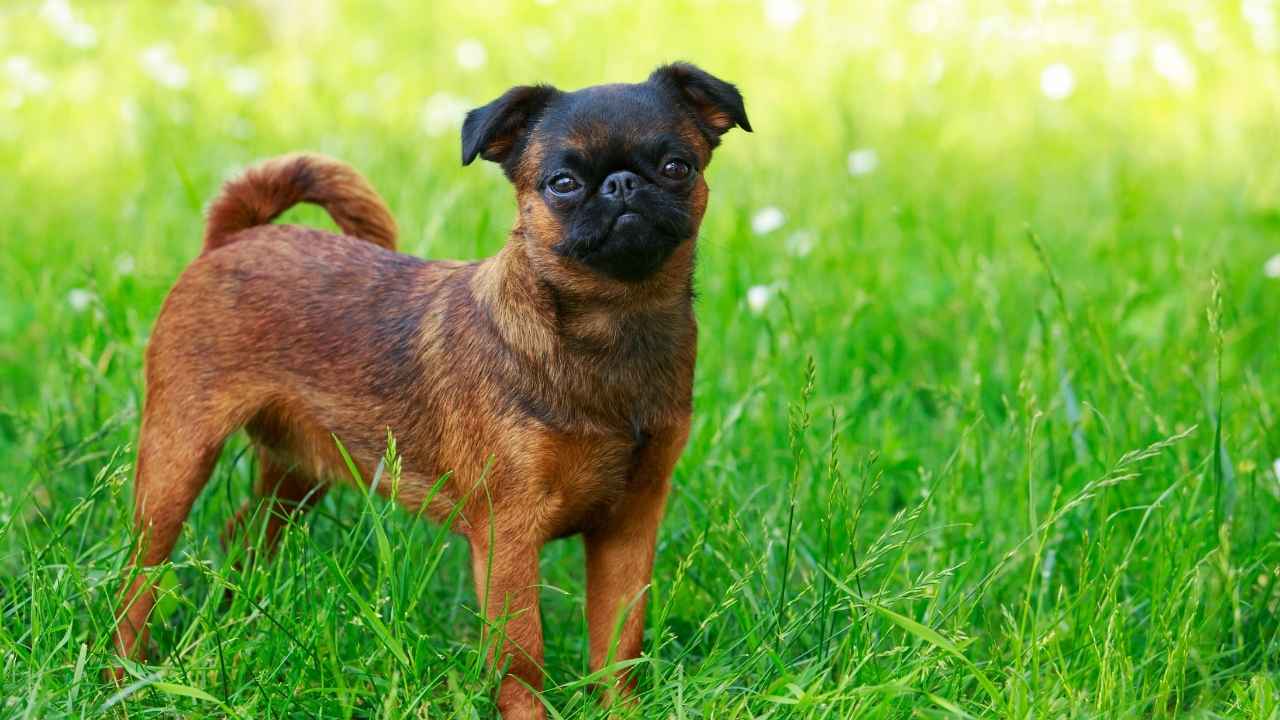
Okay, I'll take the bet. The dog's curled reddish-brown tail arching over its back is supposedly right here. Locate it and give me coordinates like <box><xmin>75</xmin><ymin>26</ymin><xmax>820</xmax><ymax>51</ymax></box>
<box><xmin>205</xmin><ymin>154</ymin><xmax>396</xmax><ymax>252</ymax></box>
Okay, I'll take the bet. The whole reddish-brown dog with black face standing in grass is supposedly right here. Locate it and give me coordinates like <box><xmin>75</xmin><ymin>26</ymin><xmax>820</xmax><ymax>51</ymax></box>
<box><xmin>115</xmin><ymin>64</ymin><xmax>750</xmax><ymax>719</ymax></box>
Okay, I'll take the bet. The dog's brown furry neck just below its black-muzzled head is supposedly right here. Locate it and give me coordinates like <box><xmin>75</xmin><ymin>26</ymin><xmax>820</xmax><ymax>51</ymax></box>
<box><xmin>472</xmin><ymin>225</ymin><xmax>694</xmax><ymax>359</ymax></box>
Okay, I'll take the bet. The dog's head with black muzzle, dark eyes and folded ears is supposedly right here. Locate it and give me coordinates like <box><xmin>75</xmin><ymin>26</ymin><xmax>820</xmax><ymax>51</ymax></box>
<box><xmin>462</xmin><ymin>63</ymin><xmax>751</xmax><ymax>283</ymax></box>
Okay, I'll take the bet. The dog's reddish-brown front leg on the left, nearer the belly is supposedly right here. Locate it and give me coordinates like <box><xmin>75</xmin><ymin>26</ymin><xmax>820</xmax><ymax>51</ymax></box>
<box><xmin>470</xmin><ymin>519</ymin><xmax>545</xmax><ymax>720</ymax></box>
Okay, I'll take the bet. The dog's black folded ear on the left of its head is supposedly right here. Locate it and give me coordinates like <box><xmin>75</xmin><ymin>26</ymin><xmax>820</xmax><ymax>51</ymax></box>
<box><xmin>462</xmin><ymin>85</ymin><xmax>559</xmax><ymax>170</ymax></box>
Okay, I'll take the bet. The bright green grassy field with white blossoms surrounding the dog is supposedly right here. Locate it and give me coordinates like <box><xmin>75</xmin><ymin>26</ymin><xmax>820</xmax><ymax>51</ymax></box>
<box><xmin>0</xmin><ymin>0</ymin><xmax>1280</xmax><ymax>719</ymax></box>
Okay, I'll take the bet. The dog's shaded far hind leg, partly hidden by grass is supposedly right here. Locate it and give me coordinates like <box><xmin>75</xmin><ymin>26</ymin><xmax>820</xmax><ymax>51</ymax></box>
<box><xmin>223</xmin><ymin>446</ymin><xmax>328</xmax><ymax>555</ymax></box>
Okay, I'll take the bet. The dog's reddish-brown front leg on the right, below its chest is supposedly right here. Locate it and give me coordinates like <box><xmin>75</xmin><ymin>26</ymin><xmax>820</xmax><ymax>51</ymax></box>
<box><xmin>582</xmin><ymin>420</ymin><xmax>689</xmax><ymax>700</ymax></box>
